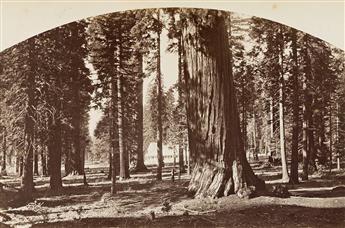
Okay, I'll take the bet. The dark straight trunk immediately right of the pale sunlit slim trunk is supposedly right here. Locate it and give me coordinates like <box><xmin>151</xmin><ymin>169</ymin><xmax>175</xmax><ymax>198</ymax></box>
<box><xmin>290</xmin><ymin>29</ymin><xmax>300</xmax><ymax>184</ymax></box>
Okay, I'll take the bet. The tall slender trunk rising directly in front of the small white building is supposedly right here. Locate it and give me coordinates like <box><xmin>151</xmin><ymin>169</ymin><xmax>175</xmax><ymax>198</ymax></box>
<box><xmin>156</xmin><ymin>9</ymin><xmax>163</xmax><ymax>180</ymax></box>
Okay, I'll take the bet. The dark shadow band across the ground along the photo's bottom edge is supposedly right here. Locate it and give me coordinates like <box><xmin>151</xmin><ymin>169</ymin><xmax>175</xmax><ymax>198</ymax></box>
<box><xmin>33</xmin><ymin>205</ymin><xmax>345</xmax><ymax>227</ymax></box>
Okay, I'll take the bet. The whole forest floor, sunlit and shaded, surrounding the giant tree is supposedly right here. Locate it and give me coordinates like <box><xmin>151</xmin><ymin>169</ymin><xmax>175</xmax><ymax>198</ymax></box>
<box><xmin>0</xmin><ymin>159</ymin><xmax>345</xmax><ymax>227</ymax></box>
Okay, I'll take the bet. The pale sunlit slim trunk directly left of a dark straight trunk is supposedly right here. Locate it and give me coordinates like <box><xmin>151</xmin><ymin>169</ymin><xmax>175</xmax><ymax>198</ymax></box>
<box><xmin>279</xmin><ymin>25</ymin><xmax>289</xmax><ymax>182</ymax></box>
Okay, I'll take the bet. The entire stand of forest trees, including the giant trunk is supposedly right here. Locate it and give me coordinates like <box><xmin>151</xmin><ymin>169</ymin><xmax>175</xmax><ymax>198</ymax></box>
<box><xmin>0</xmin><ymin>8</ymin><xmax>345</xmax><ymax>198</ymax></box>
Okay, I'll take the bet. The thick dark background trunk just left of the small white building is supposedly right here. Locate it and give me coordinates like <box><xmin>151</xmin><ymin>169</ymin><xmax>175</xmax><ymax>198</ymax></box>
<box><xmin>135</xmin><ymin>54</ymin><xmax>148</xmax><ymax>172</ymax></box>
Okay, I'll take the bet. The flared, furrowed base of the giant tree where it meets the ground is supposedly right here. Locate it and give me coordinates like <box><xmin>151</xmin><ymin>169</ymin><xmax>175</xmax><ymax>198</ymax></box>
<box><xmin>188</xmin><ymin>161</ymin><xmax>265</xmax><ymax>198</ymax></box>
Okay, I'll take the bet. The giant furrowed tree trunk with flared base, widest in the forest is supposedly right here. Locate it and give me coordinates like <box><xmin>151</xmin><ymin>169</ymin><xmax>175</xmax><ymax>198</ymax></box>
<box><xmin>183</xmin><ymin>15</ymin><xmax>265</xmax><ymax>197</ymax></box>
